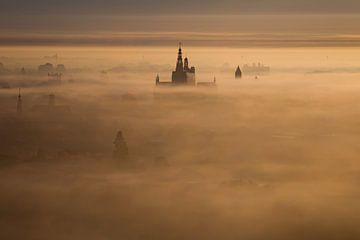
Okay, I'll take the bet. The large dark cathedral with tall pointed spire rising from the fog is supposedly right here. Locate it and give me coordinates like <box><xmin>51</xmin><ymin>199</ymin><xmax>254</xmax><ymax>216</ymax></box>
<box><xmin>156</xmin><ymin>44</ymin><xmax>195</xmax><ymax>86</ymax></box>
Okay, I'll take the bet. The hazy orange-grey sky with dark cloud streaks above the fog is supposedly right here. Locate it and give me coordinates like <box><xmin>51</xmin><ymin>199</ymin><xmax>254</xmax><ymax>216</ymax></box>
<box><xmin>0</xmin><ymin>0</ymin><xmax>360</xmax><ymax>46</ymax></box>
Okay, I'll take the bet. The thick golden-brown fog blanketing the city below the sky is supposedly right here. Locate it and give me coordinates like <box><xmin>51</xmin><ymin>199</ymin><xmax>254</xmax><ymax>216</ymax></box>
<box><xmin>0</xmin><ymin>46</ymin><xmax>360</xmax><ymax>239</ymax></box>
